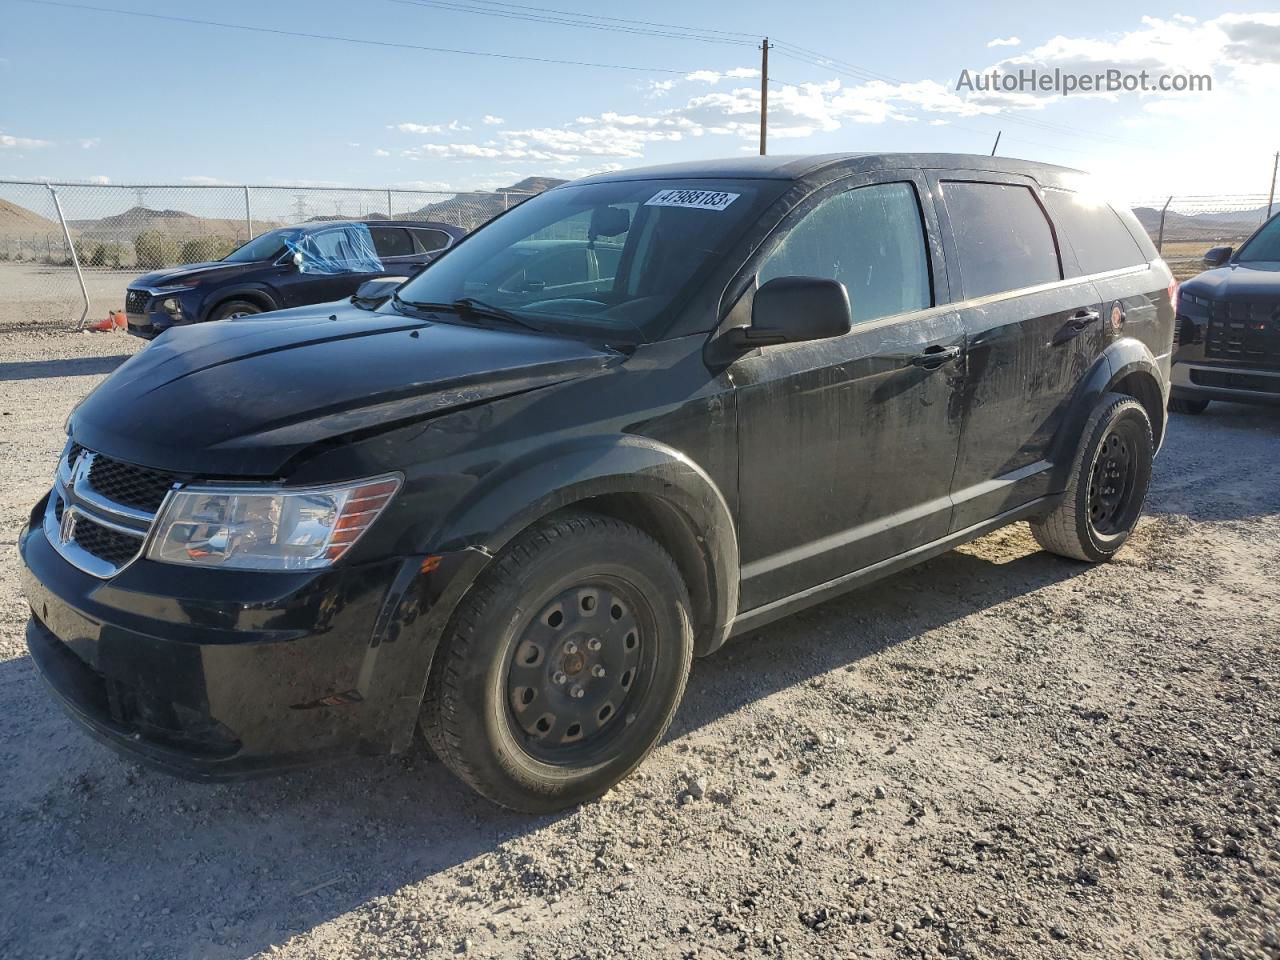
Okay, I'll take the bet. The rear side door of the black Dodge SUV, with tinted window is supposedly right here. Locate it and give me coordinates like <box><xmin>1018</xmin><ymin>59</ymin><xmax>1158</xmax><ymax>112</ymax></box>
<box><xmin>929</xmin><ymin>172</ymin><xmax>1101</xmax><ymax>531</ymax></box>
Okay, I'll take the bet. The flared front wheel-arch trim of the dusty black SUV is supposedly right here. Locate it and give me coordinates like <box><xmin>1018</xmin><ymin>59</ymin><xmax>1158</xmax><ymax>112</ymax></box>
<box><xmin>429</xmin><ymin>435</ymin><xmax>740</xmax><ymax>653</ymax></box>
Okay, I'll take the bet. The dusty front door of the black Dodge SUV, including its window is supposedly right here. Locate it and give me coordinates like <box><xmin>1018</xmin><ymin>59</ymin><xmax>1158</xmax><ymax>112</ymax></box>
<box><xmin>730</xmin><ymin>173</ymin><xmax>965</xmax><ymax>611</ymax></box>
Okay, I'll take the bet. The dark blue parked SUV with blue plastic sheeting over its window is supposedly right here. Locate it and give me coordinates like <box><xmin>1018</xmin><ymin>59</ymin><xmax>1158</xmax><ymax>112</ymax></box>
<box><xmin>124</xmin><ymin>220</ymin><xmax>466</xmax><ymax>339</ymax></box>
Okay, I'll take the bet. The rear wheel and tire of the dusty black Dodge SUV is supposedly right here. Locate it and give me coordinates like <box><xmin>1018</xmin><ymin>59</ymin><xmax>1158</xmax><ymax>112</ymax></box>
<box><xmin>1030</xmin><ymin>393</ymin><xmax>1155</xmax><ymax>563</ymax></box>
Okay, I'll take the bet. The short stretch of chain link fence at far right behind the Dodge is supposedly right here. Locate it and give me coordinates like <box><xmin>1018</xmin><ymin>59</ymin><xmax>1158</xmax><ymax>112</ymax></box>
<box><xmin>1133</xmin><ymin>195</ymin><xmax>1275</xmax><ymax>280</ymax></box>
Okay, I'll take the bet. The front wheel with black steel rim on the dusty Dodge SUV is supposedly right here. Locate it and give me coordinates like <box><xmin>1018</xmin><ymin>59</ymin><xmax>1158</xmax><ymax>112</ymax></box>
<box><xmin>421</xmin><ymin>512</ymin><xmax>694</xmax><ymax>813</ymax></box>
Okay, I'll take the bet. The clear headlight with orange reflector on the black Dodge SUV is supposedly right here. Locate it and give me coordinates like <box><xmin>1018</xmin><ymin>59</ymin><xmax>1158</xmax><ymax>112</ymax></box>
<box><xmin>147</xmin><ymin>476</ymin><xmax>401</xmax><ymax>570</ymax></box>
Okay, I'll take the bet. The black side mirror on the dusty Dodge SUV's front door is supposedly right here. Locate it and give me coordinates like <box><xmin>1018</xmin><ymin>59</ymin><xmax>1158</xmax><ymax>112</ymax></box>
<box><xmin>727</xmin><ymin>276</ymin><xmax>854</xmax><ymax>349</ymax></box>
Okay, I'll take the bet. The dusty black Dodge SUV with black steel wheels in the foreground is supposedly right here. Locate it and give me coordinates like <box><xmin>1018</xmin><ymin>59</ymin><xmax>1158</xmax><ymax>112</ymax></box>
<box><xmin>20</xmin><ymin>155</ymin><xmax>1174</xmax><ymax>810</ymax></box>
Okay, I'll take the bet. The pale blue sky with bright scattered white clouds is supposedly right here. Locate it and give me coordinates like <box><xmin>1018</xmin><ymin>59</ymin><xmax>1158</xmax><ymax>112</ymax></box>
<box><xmin>0</xmin><ymin>0</ymin><xmax>1280</xmax><ymax>201</ymax></box>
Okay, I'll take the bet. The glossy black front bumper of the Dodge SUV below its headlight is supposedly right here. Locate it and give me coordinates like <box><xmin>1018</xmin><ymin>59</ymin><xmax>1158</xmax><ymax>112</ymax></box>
<box><xmin>19</xmin><ymin>503</ymin><xmax>470</xmax><ymax>781</ymax></box>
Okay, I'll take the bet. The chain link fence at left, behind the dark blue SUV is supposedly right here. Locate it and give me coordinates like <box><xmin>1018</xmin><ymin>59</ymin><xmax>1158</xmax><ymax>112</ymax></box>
<box><xmin>0</xmin><ymin>179</ymin><xmax>535</xmax><ymax>332</ymax></box>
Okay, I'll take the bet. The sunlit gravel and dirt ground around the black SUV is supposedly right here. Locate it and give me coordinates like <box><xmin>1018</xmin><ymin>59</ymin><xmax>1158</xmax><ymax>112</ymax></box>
<box><xmin>0</xmin><ymin>323</ymin><xmax>1280</xmax><ymax>960</ymax></box>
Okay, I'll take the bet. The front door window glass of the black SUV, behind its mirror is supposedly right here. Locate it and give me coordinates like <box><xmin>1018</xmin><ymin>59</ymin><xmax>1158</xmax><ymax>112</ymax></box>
<box><xmin>756</xmin><ymin>183</ymin><xmax>933</xmax><ymax>323</ymax></box>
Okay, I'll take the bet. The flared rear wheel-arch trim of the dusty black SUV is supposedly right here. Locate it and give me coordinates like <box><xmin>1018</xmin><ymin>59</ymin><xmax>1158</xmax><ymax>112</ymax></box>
<box><xmin>1051</xmin><ymin>337</ymin><xmax>1169</xmax><ymax>492</ymax></box>
